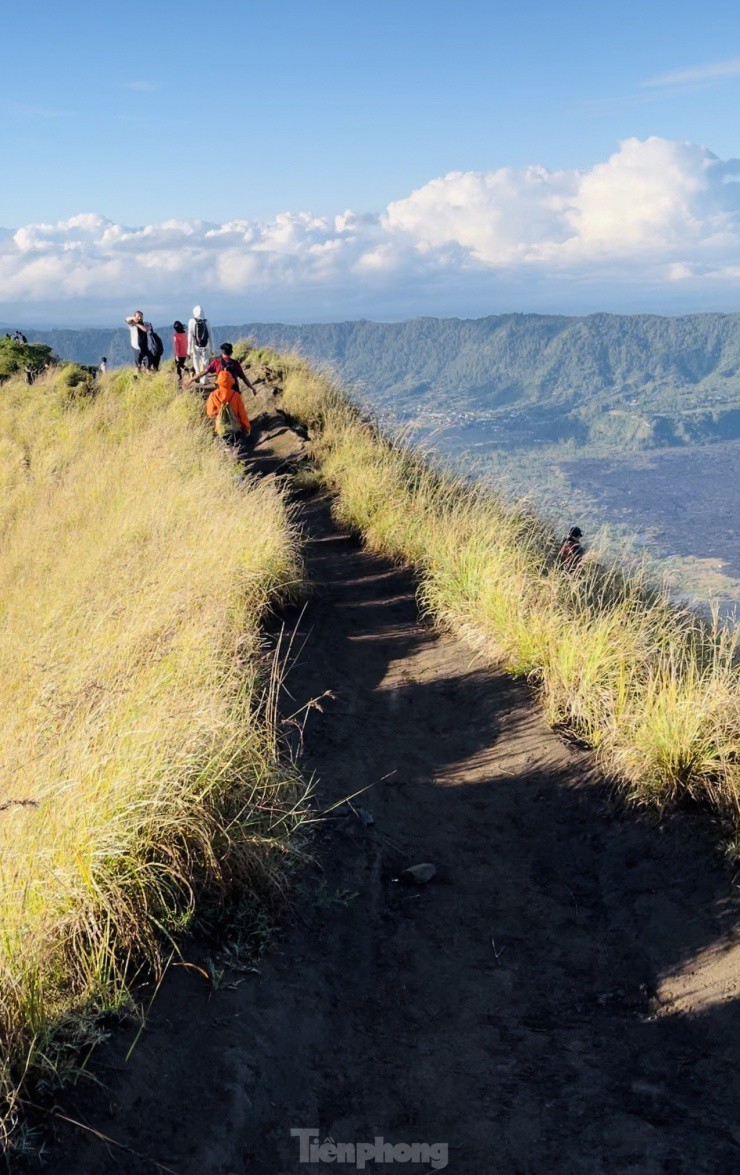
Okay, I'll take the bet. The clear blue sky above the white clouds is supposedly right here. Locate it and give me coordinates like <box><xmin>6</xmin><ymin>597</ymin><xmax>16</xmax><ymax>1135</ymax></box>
<box><xmin>0</xmin><ymin>0</ymin><xmax>740</xmax><ymax>317</ymax></box>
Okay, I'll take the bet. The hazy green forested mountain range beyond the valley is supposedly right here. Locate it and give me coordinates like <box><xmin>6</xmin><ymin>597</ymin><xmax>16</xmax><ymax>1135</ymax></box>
<box><xmin>17</xmin><ymin>314</ymin><xmax>740</xmax><ymax>448</ymax></box>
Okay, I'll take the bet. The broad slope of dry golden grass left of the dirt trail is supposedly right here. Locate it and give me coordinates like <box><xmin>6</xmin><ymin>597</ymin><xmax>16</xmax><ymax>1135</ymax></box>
<box><xmin>0</xmin><ymin>370</ymin><xmax>301</xmax><ymax>1129</ymax></box>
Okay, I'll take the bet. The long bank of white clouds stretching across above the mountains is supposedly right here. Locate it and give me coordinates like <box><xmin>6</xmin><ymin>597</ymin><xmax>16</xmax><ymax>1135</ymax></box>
<box><xmin>0</xmin><ymin>137</ymin><xmax>740</xmax><ymax>322</ymax></box>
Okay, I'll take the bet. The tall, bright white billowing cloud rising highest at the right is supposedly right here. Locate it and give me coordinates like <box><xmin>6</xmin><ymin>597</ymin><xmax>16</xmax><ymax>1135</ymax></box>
<box><xmin>383</xmin><ymin>137</ymin><xmax>740</xmax><ymax>266</ymax></box>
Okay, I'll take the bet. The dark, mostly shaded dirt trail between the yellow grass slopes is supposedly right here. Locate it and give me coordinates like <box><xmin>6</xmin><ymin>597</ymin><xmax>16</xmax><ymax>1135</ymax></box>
<box><xmin>47</xmin><ymin>392</ymin><xmax>740</xmax><ymax>1175</ymax></box>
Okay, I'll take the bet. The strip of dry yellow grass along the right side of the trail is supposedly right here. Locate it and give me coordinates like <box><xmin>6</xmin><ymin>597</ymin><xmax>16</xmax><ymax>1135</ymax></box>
<box><xmin>278</xmin><ymin>356</ymin><xmax>740</xmax><ymax>827</ymax></box>
